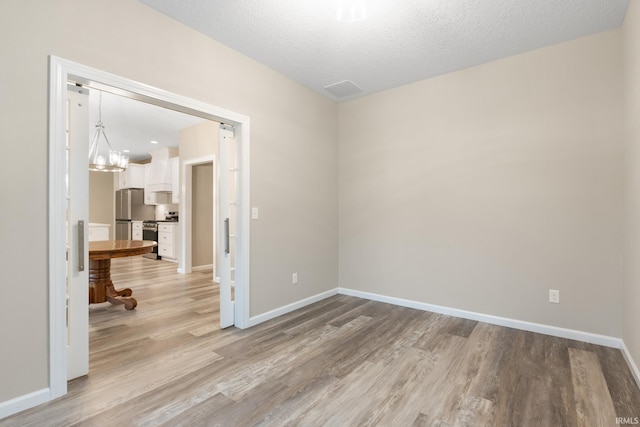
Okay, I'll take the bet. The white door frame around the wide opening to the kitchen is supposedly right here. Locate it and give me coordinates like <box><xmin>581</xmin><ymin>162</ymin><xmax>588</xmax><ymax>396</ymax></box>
<box><xmin>48</xmin><ymin>55</ymin><xmax>250</xmax><ymax>400</ymax></box>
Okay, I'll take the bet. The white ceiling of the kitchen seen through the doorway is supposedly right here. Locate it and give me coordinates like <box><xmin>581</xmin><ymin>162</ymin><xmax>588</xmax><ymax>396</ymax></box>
<box><xmin>84</xmin><ymin>89</ymin><xmax>205</xmax><ymax>161</ymax></box>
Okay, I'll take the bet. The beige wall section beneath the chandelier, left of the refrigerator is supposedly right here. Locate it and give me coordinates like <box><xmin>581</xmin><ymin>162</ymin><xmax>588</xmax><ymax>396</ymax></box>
<box><xmin>89</xmin><ymin>171</ymin><xmax>115</xmax><ymax>239</ymax></box>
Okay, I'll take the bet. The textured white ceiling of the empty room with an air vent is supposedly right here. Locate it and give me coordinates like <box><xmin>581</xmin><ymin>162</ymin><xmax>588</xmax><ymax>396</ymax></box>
<box><xmin>140</xmin><ymin>0</ymin><xmax>629</xmax><ymax>101</ymax></box>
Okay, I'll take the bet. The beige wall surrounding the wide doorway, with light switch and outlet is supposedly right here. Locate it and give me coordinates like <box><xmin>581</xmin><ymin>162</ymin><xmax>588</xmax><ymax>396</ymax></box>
<box><xmin>0</xmin><ymin>0</ymin><xmax>338</xmax><ymax>402</ymax></box>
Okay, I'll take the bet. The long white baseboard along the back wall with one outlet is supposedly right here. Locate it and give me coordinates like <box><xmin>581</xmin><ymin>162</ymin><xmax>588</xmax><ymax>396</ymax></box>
<box><xmin>338</xmin><ymin>288</ymin><xmax>622</xmax><ymax>348</ymax></box>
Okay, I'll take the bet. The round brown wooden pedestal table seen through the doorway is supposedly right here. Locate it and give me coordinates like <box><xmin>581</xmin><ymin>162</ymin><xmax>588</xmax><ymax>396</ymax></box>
<box><xmin>89</xmin><ymin>240</ymin><xmax>158</xmax><ymax>310</ymax></box>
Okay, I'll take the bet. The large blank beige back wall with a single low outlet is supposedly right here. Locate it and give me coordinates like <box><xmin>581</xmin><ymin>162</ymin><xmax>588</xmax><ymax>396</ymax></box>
<box><xmin>339</xmin><ymin>30</ymin><xmax>624</xmax><ymax>337</ymax></box>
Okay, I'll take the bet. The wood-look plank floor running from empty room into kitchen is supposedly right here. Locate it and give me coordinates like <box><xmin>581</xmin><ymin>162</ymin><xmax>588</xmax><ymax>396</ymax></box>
<box><xmin>0</xmin><ymin>257</ymin><xmax>640</xmax><ymax>426</ymax></box>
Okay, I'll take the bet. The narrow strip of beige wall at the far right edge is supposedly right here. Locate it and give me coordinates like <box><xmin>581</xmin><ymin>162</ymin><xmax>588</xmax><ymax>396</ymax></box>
<box><xmin>623</xmin><ymin>1</ymin><xmax>640</xmax><ymax>372</ymax></box>
